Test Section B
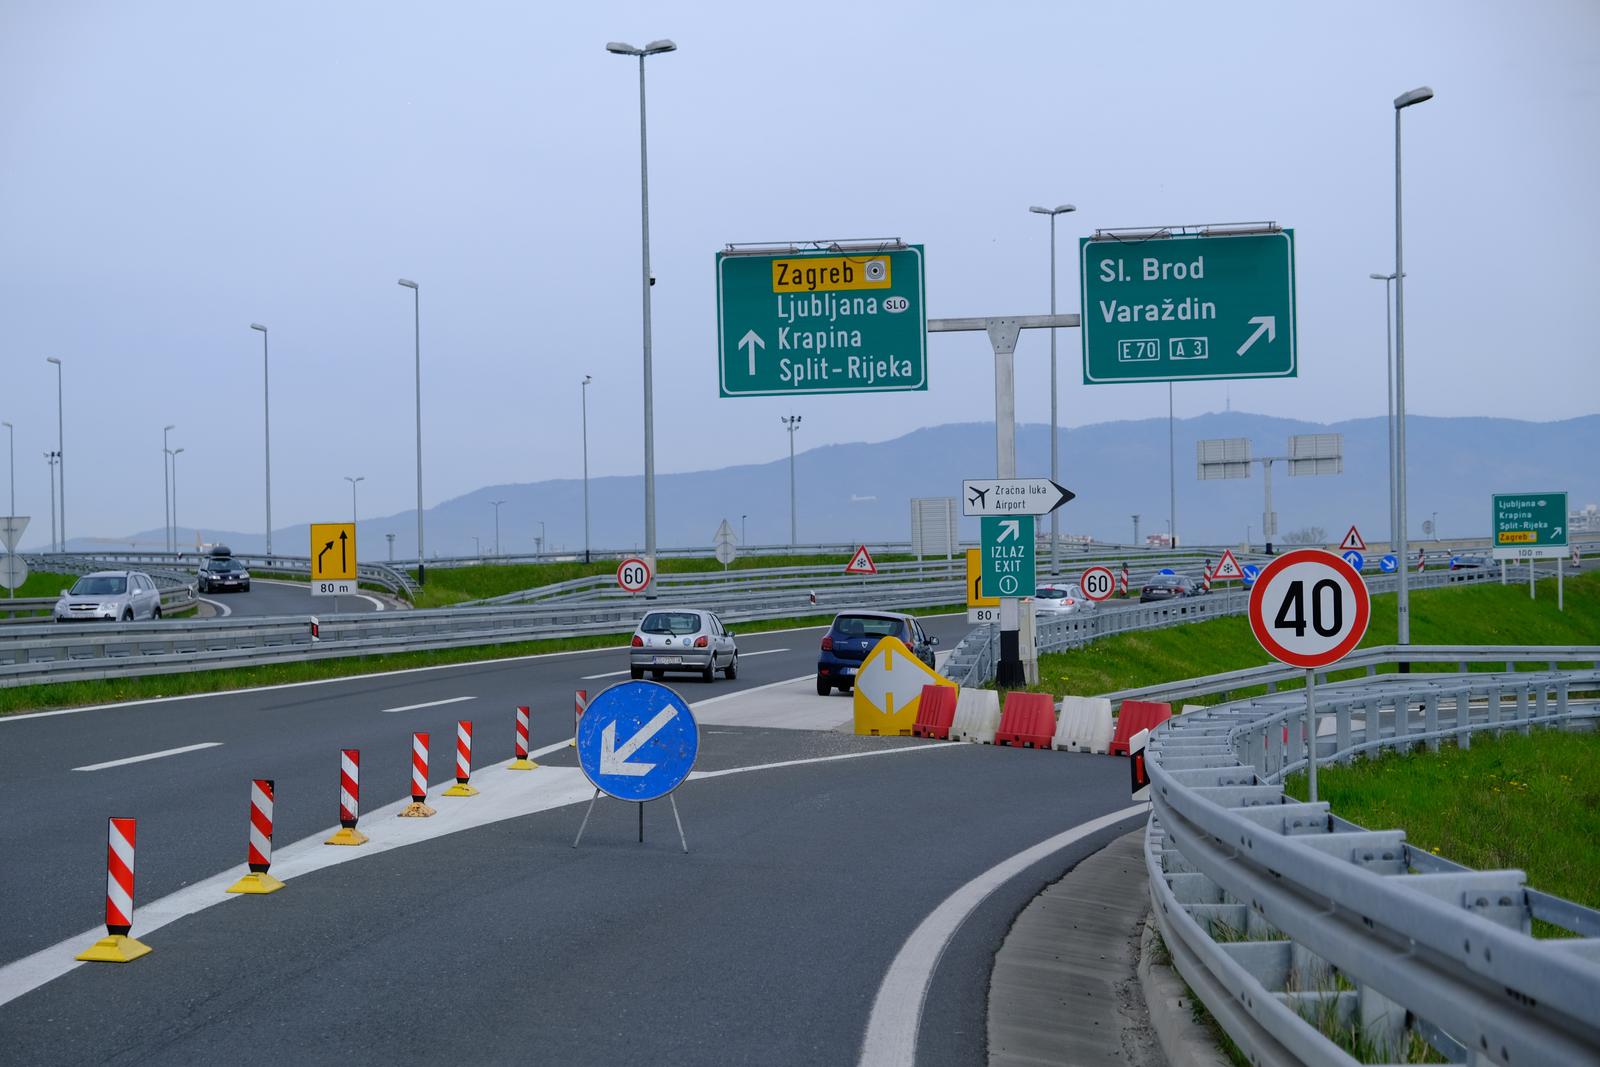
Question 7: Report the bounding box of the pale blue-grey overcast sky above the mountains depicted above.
[0,0,1600,544]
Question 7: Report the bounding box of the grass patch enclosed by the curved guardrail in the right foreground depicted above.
[1285,726,1600,907]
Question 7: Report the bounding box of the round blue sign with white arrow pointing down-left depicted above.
[578,681,699,800]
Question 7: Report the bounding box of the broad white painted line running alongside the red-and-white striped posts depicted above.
[0,741,947,1005]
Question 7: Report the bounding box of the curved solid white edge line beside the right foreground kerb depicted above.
[859,806,1150,1067]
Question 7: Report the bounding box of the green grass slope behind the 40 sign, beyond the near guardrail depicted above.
[1029,571,1600,704]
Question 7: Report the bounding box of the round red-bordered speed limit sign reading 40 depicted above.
[1250,549,1371,669]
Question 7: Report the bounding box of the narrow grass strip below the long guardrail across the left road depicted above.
[0,606,965,715]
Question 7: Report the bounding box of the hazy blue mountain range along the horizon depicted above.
[43,411,1600,560]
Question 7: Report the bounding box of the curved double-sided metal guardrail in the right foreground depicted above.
[1145,646,1600,1067]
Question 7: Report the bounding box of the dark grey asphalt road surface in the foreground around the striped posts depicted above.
[0,617,1152,1064]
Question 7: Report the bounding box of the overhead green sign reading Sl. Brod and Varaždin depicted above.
[1078,230,1296,386]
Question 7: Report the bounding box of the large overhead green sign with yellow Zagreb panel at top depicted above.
[717,245,928,397]
